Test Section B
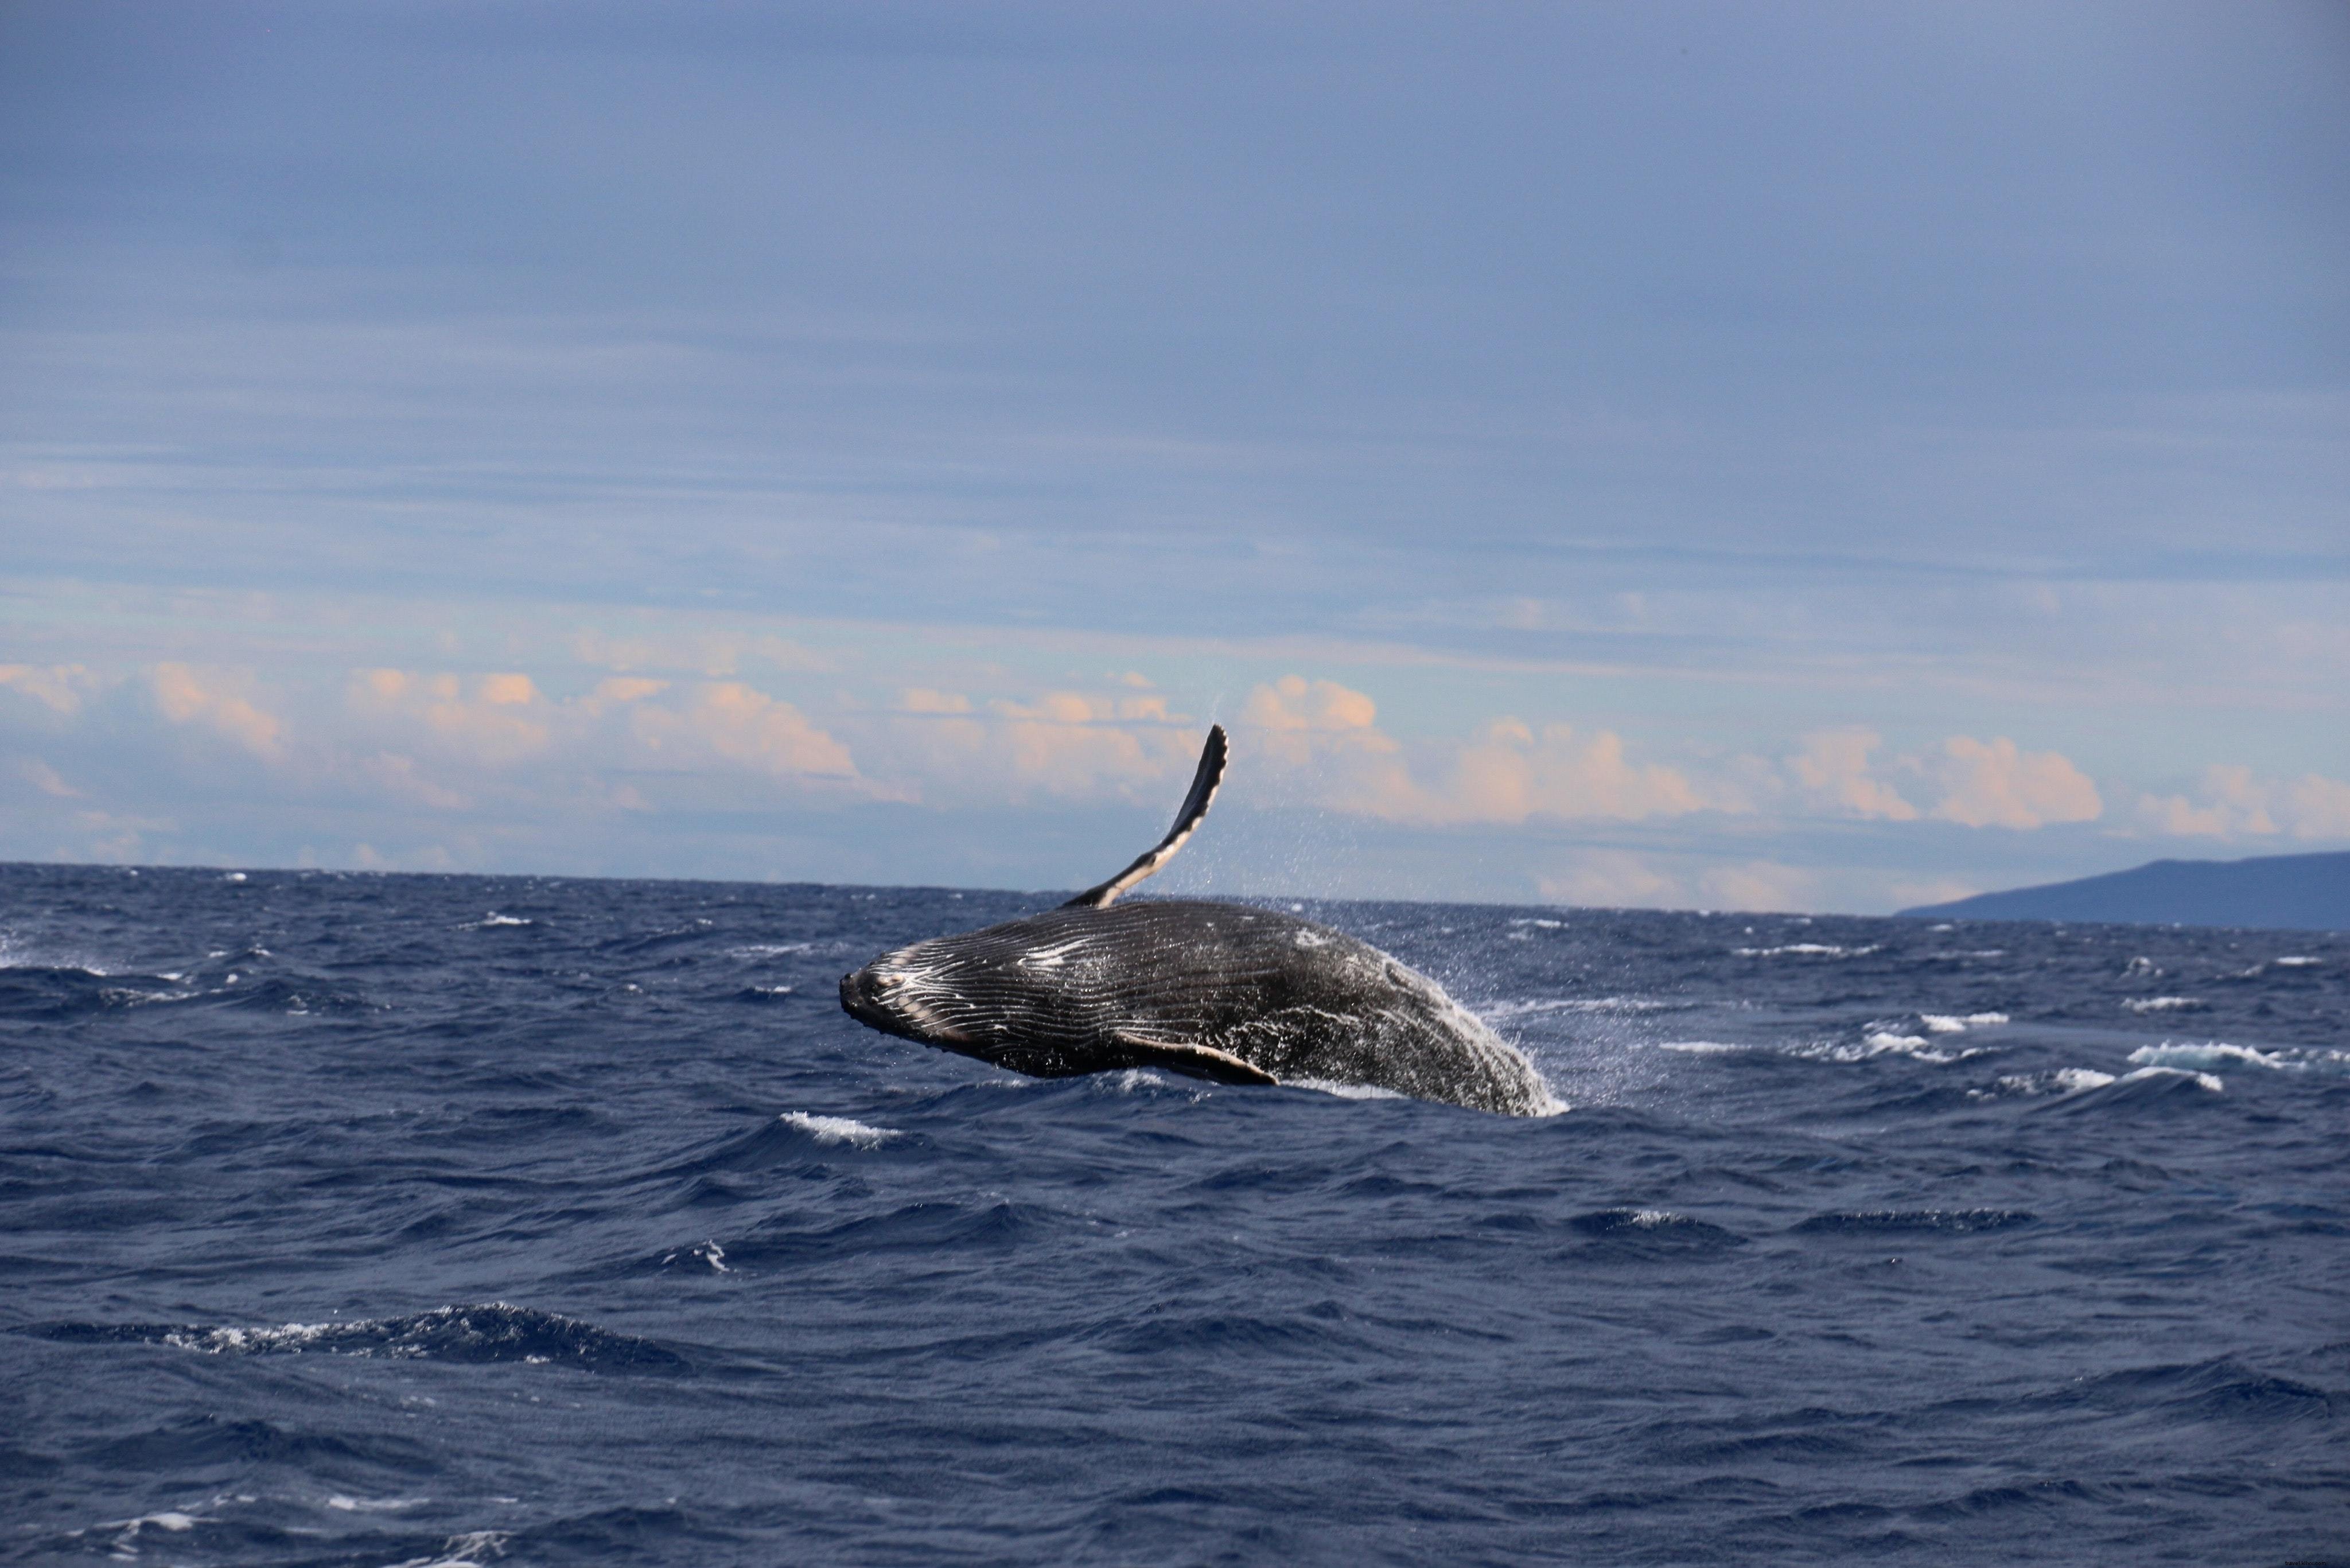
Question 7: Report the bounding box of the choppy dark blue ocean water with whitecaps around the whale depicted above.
[0,865,2350,1568]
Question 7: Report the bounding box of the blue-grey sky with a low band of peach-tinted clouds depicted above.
[0,0,2350,912]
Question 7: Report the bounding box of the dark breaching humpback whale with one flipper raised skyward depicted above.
[841,724,1563,1116]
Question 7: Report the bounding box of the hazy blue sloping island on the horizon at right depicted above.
[1901,851,2350,931]
